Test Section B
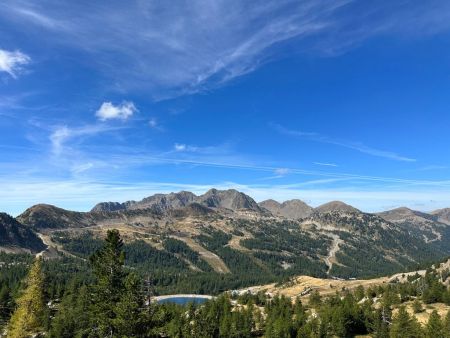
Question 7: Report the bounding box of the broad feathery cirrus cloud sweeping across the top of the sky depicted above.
[0,0,450,99]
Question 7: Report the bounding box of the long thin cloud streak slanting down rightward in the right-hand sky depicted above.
[270,123,416,162]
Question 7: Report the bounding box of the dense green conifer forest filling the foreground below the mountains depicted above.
[0,230,450,338]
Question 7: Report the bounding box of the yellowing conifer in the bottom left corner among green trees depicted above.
[8,259,46,338]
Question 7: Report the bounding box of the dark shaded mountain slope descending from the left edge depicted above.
[0,213,45,252]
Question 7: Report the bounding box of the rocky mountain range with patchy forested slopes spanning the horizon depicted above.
[0,189,450,277]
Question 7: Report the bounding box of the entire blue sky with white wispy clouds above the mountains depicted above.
[0,0,450,215]
